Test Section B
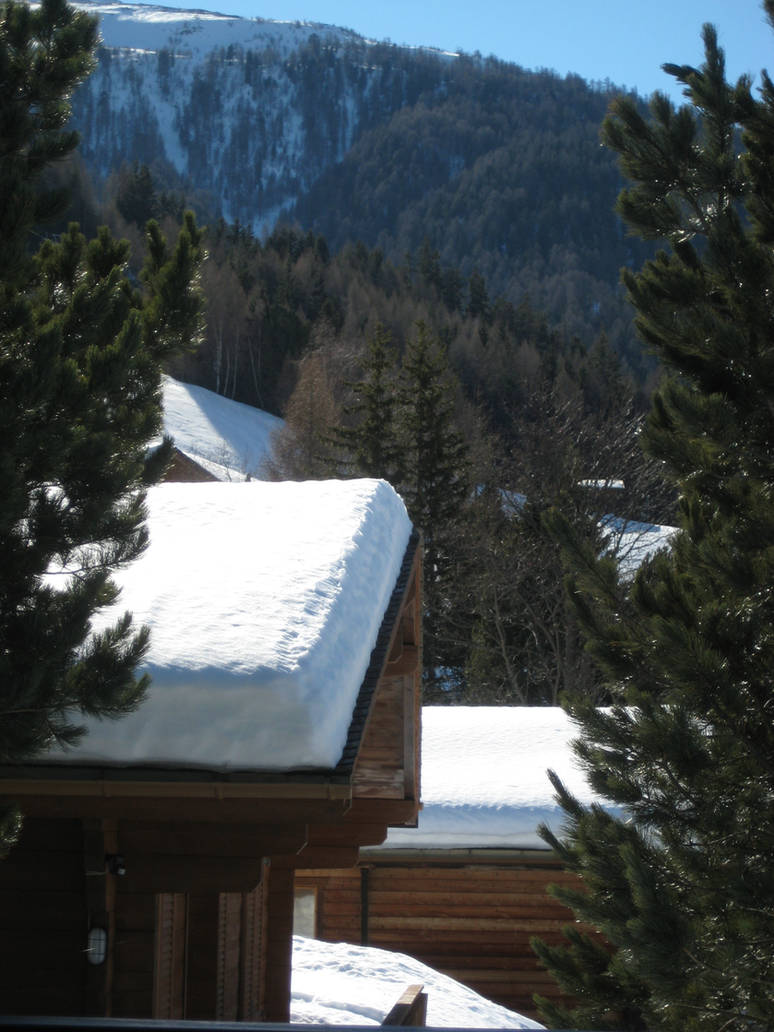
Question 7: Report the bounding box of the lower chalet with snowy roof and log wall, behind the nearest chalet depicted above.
[296,707,598,1019]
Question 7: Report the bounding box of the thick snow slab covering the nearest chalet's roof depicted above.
[47,480,411,771]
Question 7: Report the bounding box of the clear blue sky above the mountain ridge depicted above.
[139,0,774,99]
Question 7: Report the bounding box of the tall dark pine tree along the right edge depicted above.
[537,16,774,1032]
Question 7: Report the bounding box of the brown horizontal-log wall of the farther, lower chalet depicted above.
[296,850,578,1018]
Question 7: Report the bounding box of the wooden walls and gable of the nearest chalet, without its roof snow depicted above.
[0,484,421,1022]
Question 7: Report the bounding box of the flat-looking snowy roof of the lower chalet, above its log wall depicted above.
[379,706,610,849]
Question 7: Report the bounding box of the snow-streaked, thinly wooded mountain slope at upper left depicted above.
[68,0,454,230]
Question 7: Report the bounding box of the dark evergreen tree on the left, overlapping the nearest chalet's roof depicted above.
[0,0,201,830]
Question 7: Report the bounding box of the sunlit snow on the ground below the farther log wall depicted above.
[290,936,544,1029]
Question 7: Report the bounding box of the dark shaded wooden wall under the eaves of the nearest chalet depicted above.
[0,818,272,1021]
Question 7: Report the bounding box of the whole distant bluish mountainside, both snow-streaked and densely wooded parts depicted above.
[68,14,653,380]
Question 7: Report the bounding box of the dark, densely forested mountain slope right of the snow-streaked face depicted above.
[289,51,651,374]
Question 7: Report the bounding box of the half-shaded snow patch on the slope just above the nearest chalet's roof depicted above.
[163,376,283,480]
